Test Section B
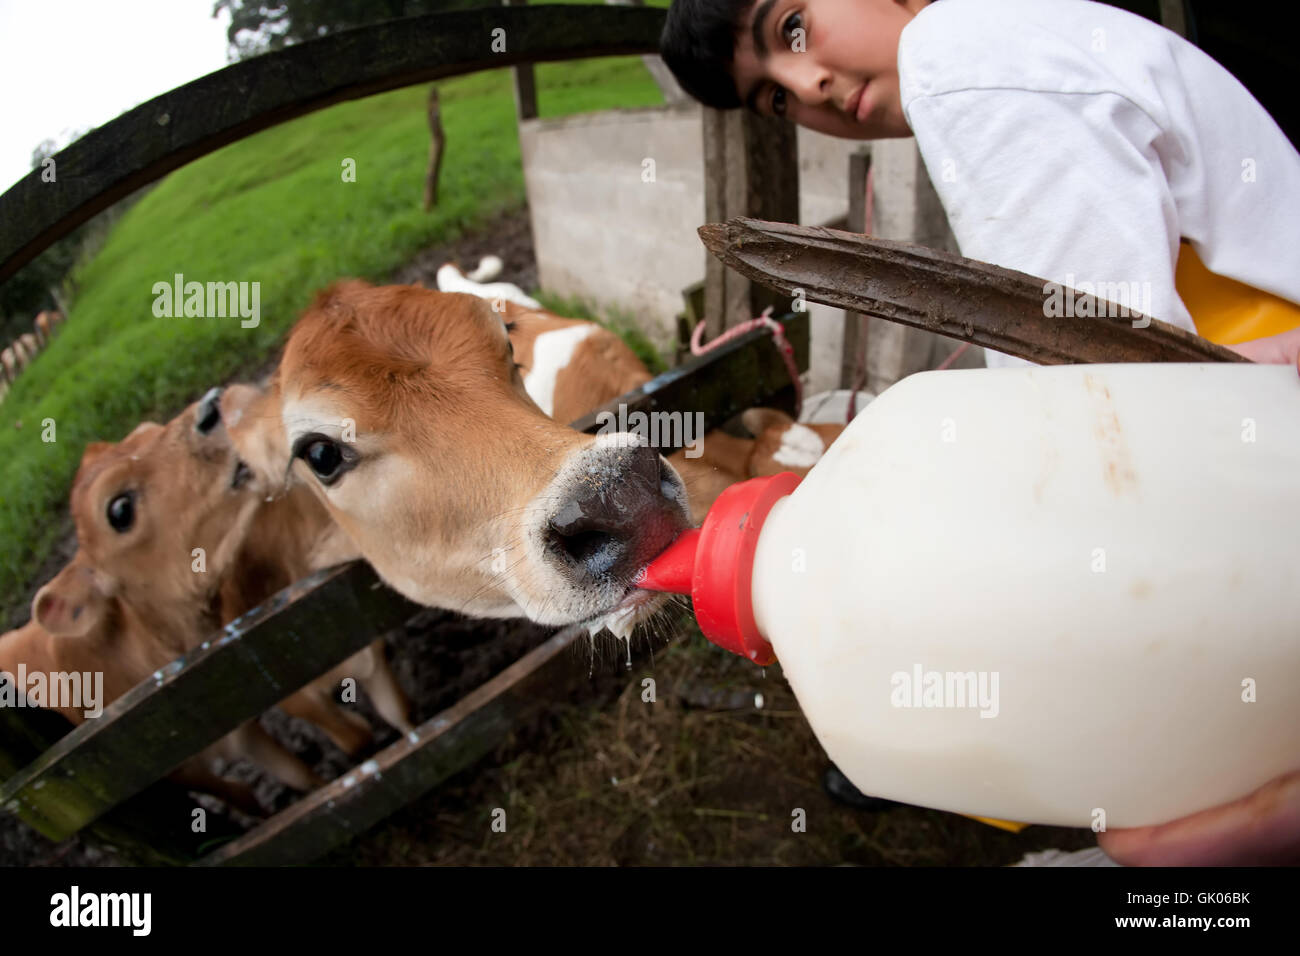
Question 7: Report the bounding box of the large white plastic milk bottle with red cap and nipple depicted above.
[644,364,1300,829]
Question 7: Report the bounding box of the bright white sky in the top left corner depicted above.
[0,0,230,193]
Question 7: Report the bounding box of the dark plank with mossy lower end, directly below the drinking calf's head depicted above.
[0,562,417,840]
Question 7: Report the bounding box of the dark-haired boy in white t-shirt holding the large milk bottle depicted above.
[660,0,1300,865]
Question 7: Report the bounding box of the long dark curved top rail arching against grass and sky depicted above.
[0,5,666,281]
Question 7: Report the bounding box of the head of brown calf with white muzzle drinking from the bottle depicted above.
[223,281,688,639]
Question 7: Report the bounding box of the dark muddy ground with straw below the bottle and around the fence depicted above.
[0,211,1095,866]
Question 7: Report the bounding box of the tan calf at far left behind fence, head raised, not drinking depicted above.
[0,394,321,814]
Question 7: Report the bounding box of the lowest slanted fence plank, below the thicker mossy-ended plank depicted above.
[199,626,588,866]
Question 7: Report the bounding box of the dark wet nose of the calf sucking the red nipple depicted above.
[546,445,688,581]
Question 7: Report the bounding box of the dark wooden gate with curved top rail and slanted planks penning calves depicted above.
[0,5,809,865]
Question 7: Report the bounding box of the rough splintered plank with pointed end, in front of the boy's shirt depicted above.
[698,219,1247,365]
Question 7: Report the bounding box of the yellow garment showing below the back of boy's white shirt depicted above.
[1174,239,1300,345]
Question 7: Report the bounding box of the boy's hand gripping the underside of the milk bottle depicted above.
[1097,770,1300,866]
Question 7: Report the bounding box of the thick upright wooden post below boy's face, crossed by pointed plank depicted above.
[703,107,800,339]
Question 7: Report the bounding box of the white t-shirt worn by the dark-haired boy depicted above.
[898,0,1300,367]
